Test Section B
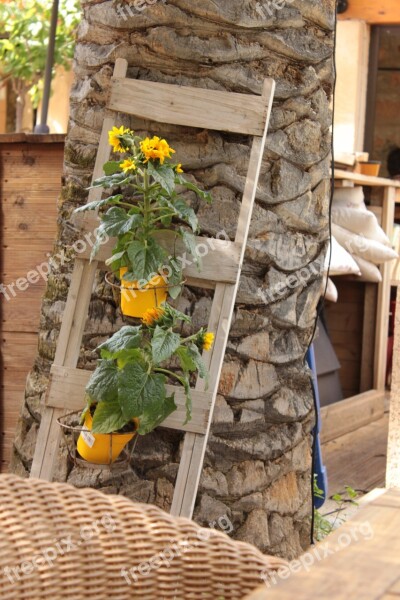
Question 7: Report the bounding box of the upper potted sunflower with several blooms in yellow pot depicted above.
[76,126,211,317]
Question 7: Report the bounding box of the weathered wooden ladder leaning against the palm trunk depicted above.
[31,59,274,518]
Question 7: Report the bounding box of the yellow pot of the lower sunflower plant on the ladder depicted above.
[76,412,139,465]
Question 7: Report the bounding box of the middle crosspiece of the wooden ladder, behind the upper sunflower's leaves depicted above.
[75,214,241,284]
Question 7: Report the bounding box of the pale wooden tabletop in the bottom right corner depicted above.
[242,490,400,600]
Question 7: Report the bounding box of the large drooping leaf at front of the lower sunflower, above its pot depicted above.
[118,362,149,421]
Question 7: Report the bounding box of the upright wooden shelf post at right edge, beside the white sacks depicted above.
[374,187,395,390]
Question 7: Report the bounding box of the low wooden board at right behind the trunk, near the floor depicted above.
[321,390,385,443]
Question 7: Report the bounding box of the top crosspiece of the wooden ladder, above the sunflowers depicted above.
[109,79,272,136]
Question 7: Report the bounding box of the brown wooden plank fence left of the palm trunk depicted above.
[0,134,65,471]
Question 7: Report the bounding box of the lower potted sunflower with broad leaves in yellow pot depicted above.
[77,304,214,464]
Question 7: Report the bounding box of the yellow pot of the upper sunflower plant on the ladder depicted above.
[120,267,168,317]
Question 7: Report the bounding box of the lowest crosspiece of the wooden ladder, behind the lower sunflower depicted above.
[46,365,212,433]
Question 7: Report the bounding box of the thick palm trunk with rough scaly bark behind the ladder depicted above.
[13,0,334,558]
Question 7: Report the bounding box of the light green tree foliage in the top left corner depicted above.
[0,0,80,129]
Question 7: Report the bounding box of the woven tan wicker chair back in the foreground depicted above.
[0,475,286,600]
